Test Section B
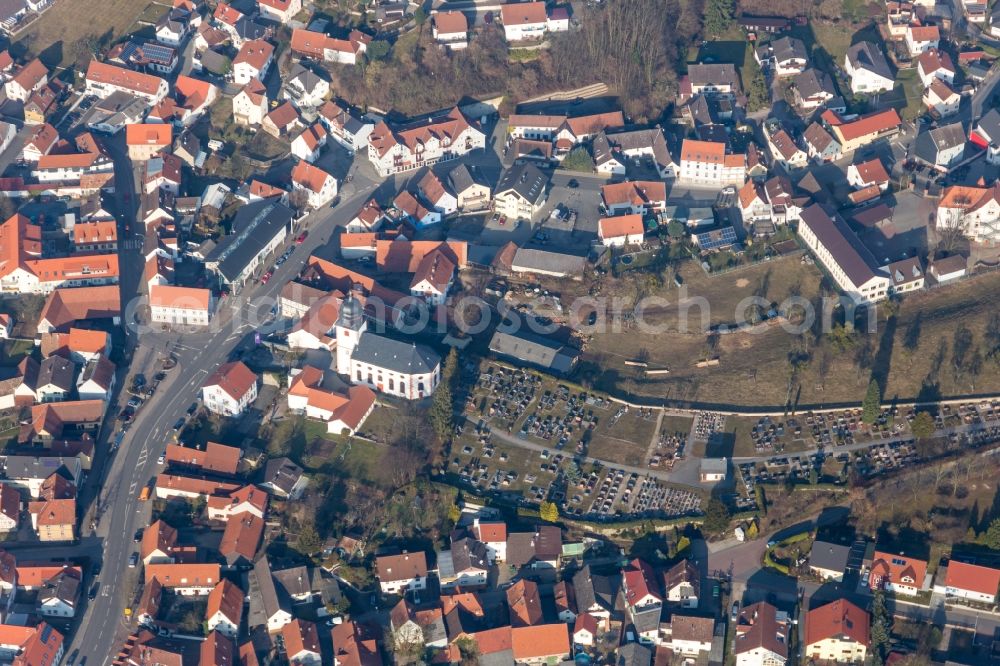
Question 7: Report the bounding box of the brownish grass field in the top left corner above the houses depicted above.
[14,0,159,67]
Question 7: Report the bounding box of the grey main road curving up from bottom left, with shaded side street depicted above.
[68,153,377,666]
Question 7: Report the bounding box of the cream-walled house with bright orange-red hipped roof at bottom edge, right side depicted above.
[803,599,871,664]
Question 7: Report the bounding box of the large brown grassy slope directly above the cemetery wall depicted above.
[586,258,1000,406]
